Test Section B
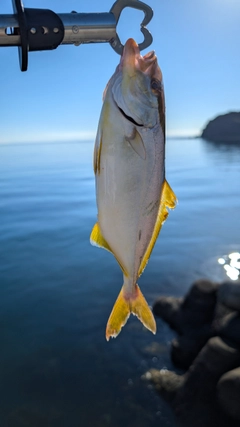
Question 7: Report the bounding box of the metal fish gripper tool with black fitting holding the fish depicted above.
[0,0,153,71]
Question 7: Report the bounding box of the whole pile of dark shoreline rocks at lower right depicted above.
[145,279,240,427]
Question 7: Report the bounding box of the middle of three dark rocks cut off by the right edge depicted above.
[216,312,240,347]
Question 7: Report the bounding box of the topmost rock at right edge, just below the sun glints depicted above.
[218,280,240,311]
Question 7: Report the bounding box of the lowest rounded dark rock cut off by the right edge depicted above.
[217,368,240,421]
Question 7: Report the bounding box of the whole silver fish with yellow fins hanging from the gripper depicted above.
[90,38,177,341]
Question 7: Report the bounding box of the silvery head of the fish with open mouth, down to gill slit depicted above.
[110,39,165,128]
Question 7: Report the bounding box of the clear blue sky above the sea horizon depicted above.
[0,0,240,142]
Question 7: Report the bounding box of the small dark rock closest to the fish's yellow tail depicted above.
[153,296,183,333]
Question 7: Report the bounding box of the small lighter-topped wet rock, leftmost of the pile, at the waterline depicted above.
[142,369,184,401]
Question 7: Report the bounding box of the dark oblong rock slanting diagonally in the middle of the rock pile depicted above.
[171,325,213,369]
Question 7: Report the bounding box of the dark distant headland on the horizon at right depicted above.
[201,112,240,143]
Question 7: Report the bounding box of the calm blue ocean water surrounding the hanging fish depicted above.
[0,139,240,427]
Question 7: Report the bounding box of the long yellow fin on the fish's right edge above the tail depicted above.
[138,180,177,277]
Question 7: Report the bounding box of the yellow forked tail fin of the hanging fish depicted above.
[106,284,156,341]
